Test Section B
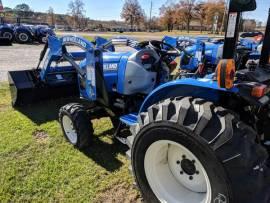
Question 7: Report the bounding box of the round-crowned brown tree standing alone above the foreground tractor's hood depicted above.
[121,0,144,30]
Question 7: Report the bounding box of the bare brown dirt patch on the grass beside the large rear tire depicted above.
[95,183,143,203]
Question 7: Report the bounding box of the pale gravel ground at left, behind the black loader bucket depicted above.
[0,44,43,82]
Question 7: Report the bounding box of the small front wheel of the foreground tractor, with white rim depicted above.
[59,103,94,149]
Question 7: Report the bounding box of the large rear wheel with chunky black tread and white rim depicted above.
[127,97,270,203]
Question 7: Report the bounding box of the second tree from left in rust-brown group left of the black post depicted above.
[178,0,196,32]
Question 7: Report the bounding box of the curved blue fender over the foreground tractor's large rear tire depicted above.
[139,76,238,113]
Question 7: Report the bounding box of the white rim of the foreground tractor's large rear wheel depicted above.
[144,140,211,203]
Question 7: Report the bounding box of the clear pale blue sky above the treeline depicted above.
[2,0,270,22]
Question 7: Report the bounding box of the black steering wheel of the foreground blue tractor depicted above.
[148,40,181,57]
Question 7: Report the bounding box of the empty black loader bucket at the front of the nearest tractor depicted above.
[8,70,79,107]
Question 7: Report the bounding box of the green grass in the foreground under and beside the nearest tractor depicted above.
[0,83,140,202]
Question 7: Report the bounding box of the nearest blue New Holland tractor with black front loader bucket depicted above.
[9,0,270,203]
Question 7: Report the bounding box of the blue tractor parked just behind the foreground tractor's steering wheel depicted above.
[162,36,224,77]
